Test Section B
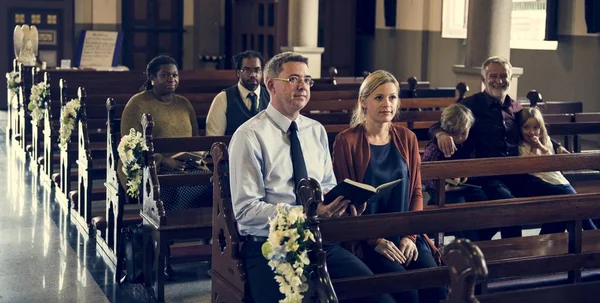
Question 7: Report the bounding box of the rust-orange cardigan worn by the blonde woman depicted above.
[333,124,438,256]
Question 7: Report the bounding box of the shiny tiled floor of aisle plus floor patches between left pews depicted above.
[0,111,210,303]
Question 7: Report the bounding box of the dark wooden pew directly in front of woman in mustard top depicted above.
[140,114,228,302]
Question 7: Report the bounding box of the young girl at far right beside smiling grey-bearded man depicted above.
[519,107,596,234]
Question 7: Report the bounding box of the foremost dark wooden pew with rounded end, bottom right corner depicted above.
[444,239,600,303]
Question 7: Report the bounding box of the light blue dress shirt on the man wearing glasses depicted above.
[228,104,336,236]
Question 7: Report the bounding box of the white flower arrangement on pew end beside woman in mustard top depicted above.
[117,128,148,199]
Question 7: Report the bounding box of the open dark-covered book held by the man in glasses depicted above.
[323,179,402,207]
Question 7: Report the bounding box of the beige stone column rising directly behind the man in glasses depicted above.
[281,0,325,79]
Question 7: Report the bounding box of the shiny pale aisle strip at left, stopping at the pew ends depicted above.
[0,126,109,302]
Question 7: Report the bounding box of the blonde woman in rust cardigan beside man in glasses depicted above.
[333,70,447,302]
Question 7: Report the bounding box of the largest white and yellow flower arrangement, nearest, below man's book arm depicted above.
[262,203,315,303]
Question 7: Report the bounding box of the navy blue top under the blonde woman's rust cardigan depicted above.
[362,142,410,245]
